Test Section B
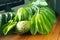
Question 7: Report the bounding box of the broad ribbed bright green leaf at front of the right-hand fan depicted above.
[38,12,52,34]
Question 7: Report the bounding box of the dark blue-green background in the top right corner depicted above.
[47,0,60,15]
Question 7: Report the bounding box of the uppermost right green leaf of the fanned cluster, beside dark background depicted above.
[41,7,56,23]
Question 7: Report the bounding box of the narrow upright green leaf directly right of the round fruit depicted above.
[30,14,39,35]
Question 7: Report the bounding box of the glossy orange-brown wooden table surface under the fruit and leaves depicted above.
[0,16,60,40]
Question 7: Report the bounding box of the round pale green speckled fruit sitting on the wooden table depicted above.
[16,21,30,34]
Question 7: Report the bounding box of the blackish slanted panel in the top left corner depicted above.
[0,0,24,11]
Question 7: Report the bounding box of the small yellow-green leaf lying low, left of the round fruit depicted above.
[3,21,16,35]
